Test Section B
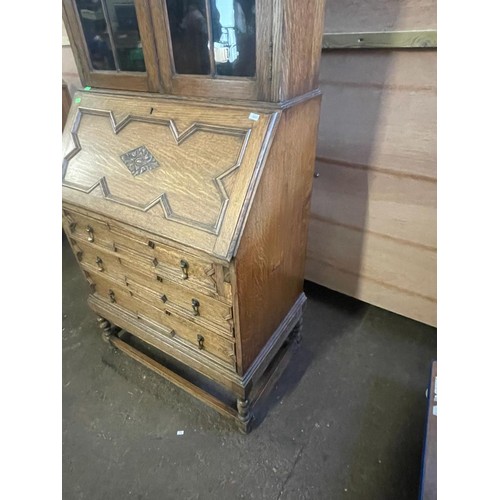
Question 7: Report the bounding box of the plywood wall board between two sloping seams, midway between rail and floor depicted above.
[311,161,436,250]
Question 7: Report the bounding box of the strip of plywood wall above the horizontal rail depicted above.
[325,0,437,33]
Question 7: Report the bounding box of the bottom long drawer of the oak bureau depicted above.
[86,272,236,368]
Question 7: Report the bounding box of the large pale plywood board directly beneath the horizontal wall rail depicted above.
[317,51,436,178]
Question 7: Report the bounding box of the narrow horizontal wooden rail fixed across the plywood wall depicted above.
[322,30,437,50]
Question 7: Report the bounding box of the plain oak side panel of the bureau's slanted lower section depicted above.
[233,97,321,374]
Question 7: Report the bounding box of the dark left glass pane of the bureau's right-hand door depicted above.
[166,0,210,75]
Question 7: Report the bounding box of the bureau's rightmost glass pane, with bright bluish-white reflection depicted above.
[210,0,256,76]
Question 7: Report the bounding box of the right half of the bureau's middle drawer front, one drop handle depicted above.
[126,272,233,337]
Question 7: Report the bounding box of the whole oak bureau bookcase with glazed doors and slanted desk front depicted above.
[62,0,324,432]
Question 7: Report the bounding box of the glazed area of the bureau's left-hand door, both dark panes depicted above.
[75,0,146,72]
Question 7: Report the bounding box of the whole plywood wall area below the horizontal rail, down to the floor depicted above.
[306,50,436,325]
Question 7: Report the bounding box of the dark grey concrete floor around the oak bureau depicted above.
[62,238,436,500]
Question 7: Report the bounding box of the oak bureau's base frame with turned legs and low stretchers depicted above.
[93,294,305,434]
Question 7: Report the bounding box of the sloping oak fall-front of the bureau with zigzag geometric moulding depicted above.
[63,92,275,260]
